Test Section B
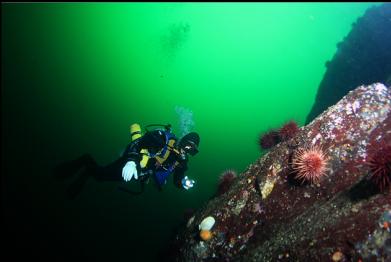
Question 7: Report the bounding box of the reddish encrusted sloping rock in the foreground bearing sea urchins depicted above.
[168,84,391,261]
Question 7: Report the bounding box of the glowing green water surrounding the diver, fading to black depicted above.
[1,3,380,261]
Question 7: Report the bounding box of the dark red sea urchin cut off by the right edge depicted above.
[368,142,391,191]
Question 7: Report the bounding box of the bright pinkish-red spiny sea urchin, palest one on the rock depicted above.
[292,143,329,183]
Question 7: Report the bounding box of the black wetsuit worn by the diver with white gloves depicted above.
[54,130,188,197]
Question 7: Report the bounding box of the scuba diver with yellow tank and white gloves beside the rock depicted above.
[54,124,200,198]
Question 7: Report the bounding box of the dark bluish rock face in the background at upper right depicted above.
[306,3,391,124]
